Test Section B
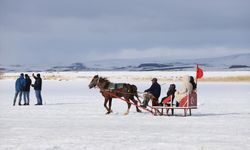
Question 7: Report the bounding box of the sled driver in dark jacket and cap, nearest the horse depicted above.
[141,78,161,107]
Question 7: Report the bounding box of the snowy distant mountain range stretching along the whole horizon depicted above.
[0,53,250,72]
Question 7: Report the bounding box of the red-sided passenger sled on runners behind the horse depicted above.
[152,91,197,116]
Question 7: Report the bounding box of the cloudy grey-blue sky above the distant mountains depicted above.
[0,0,250,64]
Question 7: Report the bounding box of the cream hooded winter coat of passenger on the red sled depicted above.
[175,76,193,102]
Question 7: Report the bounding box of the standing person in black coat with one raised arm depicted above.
[31,73,43,105]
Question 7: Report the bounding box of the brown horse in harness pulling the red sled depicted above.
[89,75,141,115]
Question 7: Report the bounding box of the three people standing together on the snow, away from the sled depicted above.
[13,73,43,106]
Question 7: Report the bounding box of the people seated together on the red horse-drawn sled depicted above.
[141,76,197,107]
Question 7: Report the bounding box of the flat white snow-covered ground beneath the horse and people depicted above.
[0,72,250,150]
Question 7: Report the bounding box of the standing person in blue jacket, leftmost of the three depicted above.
[13,73,26,106]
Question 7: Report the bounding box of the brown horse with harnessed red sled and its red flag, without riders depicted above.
[89,66,203,116]
